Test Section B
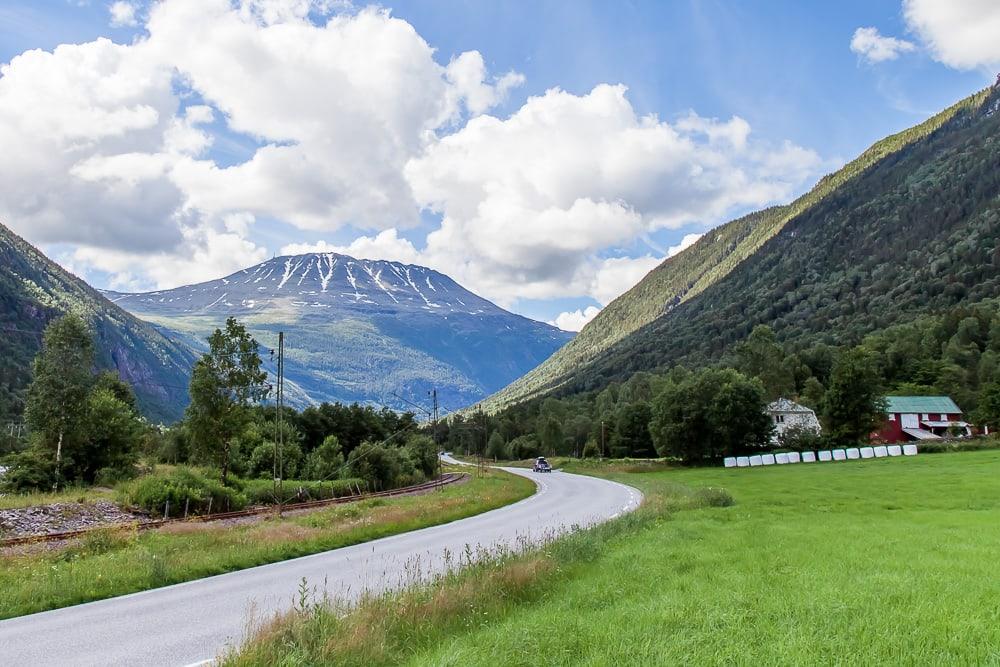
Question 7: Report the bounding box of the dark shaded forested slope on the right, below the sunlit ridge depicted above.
[566,81,1000,391]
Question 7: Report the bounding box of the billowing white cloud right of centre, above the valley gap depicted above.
[405,85,820,303]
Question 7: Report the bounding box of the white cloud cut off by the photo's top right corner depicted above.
[903,0,1000,73]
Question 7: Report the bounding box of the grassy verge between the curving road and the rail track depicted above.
[0,471,535,618]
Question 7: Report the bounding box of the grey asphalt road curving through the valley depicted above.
[0,468,642,667]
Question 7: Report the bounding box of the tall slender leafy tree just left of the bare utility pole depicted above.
[187,317,267,484]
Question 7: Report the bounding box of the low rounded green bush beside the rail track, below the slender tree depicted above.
[117,468,247,517]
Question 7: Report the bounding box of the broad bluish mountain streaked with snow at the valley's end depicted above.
[105,253,572,409]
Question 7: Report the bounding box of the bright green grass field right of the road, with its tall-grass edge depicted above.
[228,451,1000,665]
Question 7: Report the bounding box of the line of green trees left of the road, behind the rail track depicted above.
[2,315,438,491]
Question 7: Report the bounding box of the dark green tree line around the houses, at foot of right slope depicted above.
[468,301,1000,461]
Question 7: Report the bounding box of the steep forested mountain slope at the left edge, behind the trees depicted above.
[0,225,194,422]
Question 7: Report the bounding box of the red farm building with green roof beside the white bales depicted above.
[877,396,972,443]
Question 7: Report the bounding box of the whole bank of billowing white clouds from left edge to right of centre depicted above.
[0,0,821,306]
